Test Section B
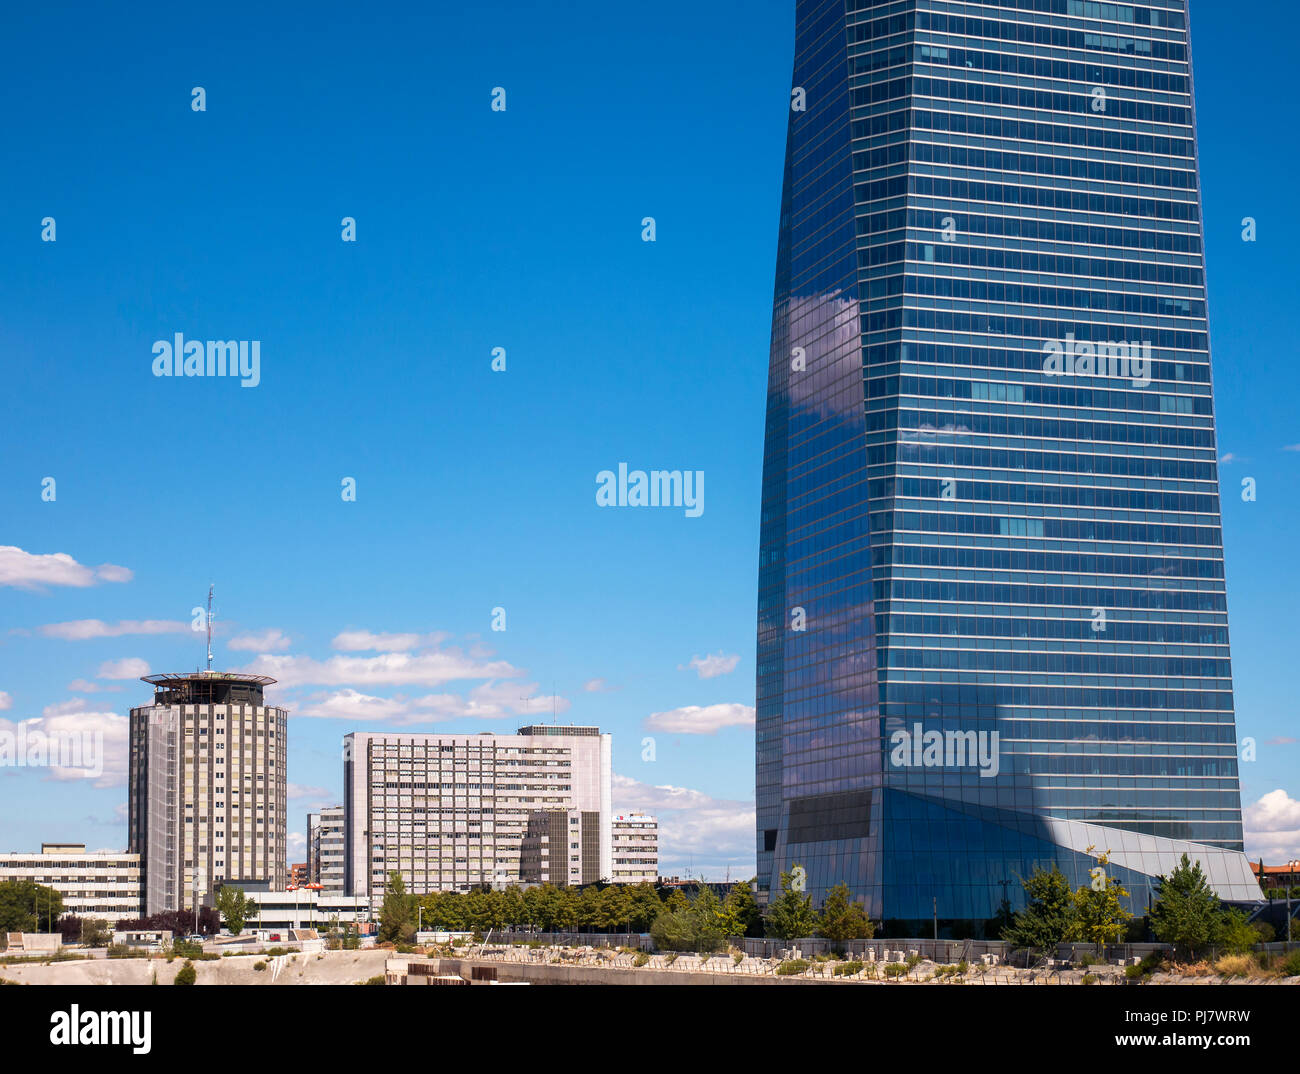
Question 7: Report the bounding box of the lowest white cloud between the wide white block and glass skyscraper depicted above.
[614,774,754,879]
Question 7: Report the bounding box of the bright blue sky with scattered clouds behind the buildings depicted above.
[0,0,1300,876]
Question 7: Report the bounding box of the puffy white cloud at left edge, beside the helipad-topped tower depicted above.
[0,701,130,787]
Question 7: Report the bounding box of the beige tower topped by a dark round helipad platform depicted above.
[127,671,289,914]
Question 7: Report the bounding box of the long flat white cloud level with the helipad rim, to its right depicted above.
[239,649,520,687]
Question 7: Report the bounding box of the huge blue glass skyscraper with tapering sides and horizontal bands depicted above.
[757,0,1260,935]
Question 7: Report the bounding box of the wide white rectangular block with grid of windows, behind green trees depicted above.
[343,724,614,905]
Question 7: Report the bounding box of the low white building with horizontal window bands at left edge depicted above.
[0,843,142,915]
